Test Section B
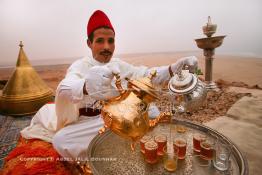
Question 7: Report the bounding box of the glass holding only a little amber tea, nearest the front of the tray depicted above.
[163,147,178,172]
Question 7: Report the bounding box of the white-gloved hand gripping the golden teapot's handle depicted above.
[84,66,119,100]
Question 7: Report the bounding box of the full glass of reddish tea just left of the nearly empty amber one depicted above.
[145,140,157,164]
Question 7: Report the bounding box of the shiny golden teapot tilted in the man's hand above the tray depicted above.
[101,71,168,145]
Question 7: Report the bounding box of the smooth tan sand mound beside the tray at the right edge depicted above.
[205,88,262,175]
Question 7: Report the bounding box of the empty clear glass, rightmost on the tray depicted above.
[213,140,232,171]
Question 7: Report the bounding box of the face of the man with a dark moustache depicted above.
[87,28,115,63]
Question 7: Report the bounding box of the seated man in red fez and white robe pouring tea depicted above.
[21,10,197,161]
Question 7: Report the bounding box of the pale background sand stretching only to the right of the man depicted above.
[120,52,262,87]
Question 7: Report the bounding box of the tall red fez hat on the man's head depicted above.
[87,10,115,36]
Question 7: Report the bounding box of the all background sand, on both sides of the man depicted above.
[0,52,262,90]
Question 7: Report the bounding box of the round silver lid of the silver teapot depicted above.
[168,70,197,94]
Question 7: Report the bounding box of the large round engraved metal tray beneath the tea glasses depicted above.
[88,119,248,175]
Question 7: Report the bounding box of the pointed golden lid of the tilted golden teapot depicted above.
[127,72,158,99]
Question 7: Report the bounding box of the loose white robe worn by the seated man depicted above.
[21,57,162,160]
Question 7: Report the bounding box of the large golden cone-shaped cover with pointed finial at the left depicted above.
[0,41,53,116]
